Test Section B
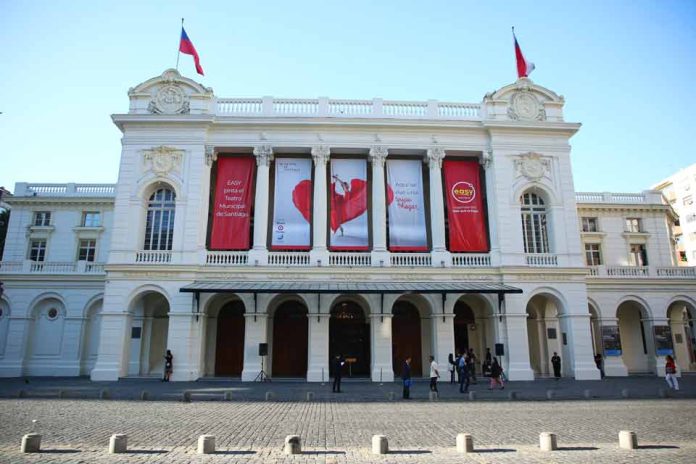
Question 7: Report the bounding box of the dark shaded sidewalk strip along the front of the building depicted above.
[0,374,696,402]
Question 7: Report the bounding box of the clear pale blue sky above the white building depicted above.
[0,0,696,192]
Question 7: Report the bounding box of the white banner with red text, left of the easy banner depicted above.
[387,160,428,251]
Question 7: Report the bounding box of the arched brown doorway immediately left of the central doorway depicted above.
[272,300,308,377]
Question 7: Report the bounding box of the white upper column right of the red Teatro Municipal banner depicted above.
[249,145,273,266]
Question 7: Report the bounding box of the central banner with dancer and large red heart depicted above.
[329,159,370,250]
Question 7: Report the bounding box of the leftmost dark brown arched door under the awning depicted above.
[215,301,244,377]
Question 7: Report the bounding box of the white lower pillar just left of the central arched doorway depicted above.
[304,294,336,382]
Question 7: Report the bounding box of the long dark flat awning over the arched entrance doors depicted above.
[179,281,522,296]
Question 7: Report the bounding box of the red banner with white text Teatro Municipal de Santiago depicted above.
[210,156,254,250]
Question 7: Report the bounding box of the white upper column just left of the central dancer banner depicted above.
[309,145,331,266]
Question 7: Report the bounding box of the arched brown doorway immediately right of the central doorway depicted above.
[392,301,423,377]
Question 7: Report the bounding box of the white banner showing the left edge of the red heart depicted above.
[271,158,312,250]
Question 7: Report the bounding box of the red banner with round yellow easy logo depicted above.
[443,159,488,252]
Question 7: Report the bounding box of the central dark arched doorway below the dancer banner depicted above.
[329,301,370,377]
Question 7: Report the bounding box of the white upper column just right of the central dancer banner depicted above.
[370,145,391,267]
